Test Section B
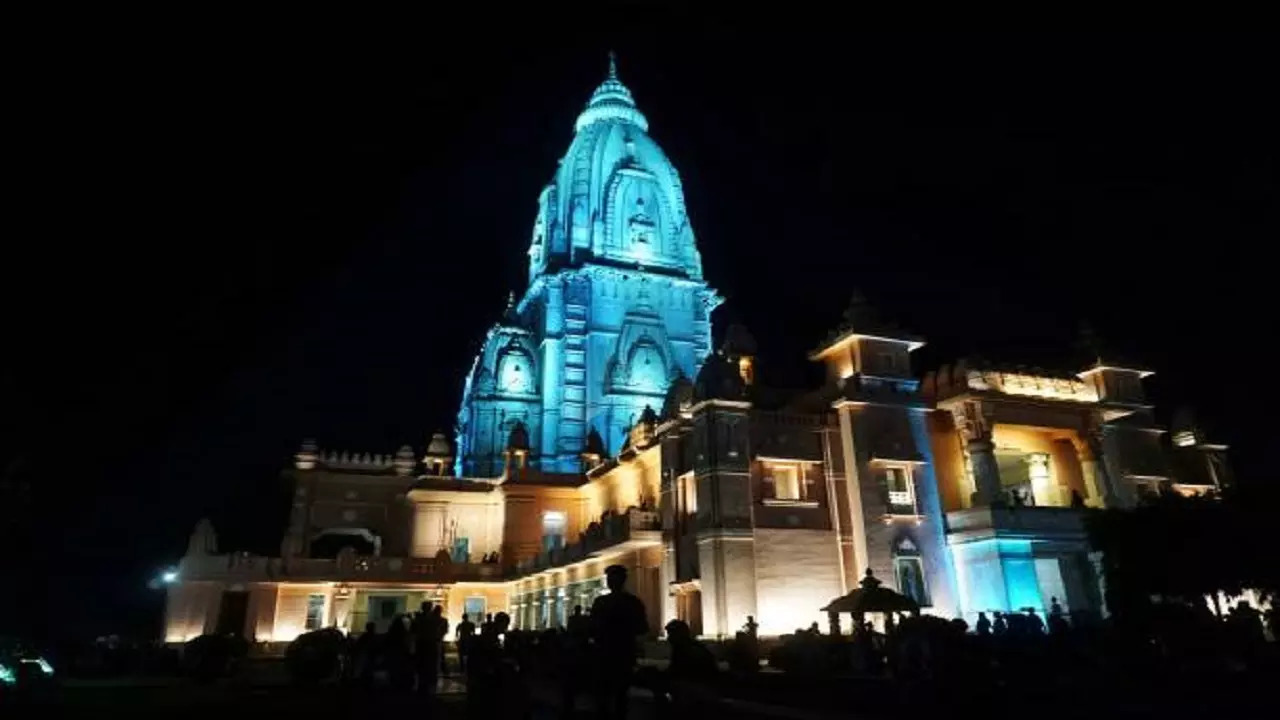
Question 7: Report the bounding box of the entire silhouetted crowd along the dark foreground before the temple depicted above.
[320,566,1262,719]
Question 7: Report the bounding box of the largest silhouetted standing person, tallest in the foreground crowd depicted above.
[591,565,649,720]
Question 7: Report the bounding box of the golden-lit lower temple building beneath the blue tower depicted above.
[166,313,1229,638]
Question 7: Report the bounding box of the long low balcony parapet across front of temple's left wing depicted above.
[179,553,502,584]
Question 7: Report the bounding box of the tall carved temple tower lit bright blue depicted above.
[457,55,721,475]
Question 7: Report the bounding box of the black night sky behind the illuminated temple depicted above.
[0,23,1280,634]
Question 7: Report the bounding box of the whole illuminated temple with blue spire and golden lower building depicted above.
[165,57,1230,651]
